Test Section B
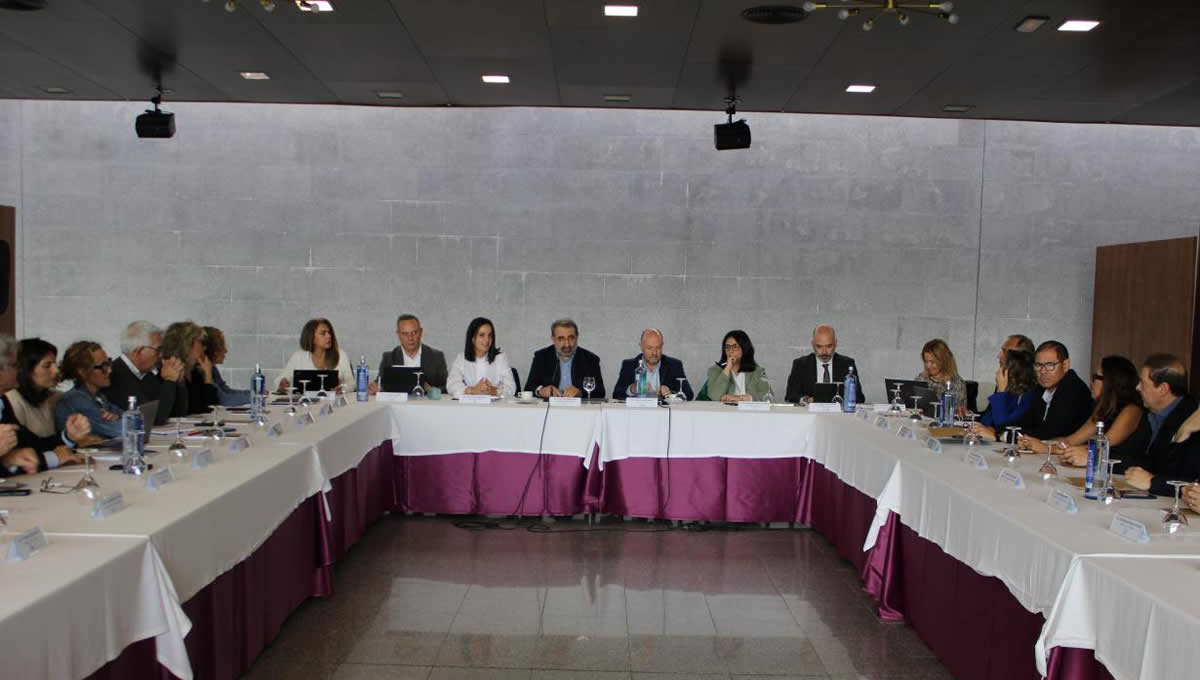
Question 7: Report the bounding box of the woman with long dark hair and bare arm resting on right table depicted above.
[1021,355,1150,462]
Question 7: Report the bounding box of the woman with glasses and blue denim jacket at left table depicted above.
[54,341,125,439]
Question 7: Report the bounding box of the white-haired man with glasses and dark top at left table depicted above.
[104,321,187,425]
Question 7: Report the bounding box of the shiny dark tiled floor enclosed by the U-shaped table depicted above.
[241,516,952,680]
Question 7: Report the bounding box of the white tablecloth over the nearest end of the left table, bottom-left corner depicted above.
[0,532,192,680]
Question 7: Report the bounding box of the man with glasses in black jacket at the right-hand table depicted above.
[1018,341,1092,440]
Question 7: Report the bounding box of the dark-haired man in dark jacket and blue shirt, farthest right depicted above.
[1115,354,1200,495]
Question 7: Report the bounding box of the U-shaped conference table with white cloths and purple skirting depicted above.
[0,399,1200,680]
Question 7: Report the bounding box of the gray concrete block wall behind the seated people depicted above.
[0,102,1200,398]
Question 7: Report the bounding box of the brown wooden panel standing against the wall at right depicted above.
[1094,236,1200,384]
